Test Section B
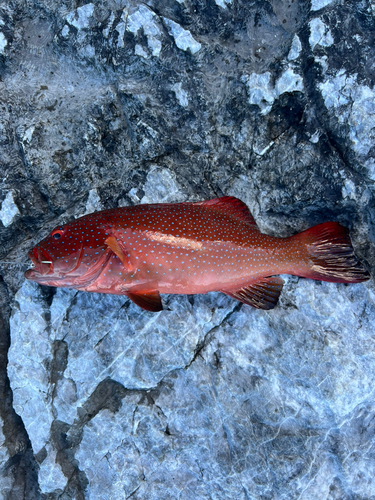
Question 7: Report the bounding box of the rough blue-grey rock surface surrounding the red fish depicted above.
[0,0,375,500]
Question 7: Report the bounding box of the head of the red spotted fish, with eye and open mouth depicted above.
[25,216,108,287]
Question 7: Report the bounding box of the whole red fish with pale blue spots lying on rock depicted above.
[25,196,370,312]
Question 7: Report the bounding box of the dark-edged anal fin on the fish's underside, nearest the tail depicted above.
[221,276,284,309]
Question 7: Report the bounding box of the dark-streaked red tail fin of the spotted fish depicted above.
[292,222,370,283]
